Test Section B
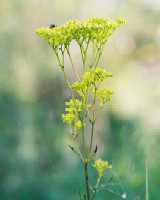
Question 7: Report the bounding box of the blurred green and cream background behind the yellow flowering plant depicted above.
[0,0,160,200]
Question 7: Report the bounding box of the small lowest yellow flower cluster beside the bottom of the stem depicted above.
[92,159,112,177]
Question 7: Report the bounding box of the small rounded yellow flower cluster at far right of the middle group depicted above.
[97,87,114,107]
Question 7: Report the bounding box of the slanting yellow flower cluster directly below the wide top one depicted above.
[72,68,112,96]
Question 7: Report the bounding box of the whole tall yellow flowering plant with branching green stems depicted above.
[35,17,125,200]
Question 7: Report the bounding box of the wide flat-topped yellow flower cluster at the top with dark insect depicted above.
[35,17,125,49]
